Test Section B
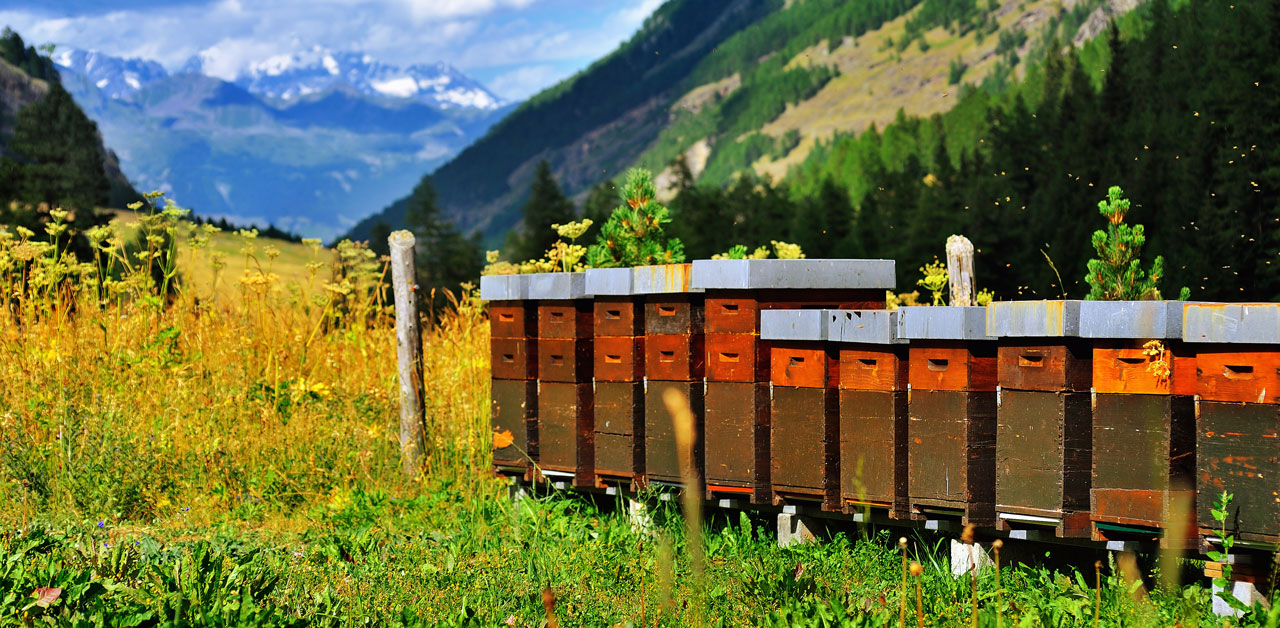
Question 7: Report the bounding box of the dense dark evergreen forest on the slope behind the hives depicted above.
[650,0,1280,301]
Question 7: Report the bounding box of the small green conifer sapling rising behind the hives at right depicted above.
[1084,185,1190,301]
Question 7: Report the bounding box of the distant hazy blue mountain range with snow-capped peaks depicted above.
[54,47,511,238]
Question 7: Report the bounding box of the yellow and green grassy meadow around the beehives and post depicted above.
[0,204,1276,627]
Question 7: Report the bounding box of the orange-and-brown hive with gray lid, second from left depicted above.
[529,272,595,486]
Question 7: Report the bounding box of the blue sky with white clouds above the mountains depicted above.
[0,0,662,100]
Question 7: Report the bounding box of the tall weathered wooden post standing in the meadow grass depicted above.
[387,230,426,477]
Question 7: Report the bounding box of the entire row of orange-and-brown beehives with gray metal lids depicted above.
[481,260,1280,546]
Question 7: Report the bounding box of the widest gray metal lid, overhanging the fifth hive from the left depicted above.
[692,260,893,290]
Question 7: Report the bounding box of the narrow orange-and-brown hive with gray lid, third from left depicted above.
[586,269,645,486]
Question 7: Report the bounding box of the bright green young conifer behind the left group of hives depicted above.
[586,168,685,269]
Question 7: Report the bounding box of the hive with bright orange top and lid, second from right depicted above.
[1080,301,1196,549]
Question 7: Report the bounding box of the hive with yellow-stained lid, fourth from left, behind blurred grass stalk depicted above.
[632,263,704,490]
